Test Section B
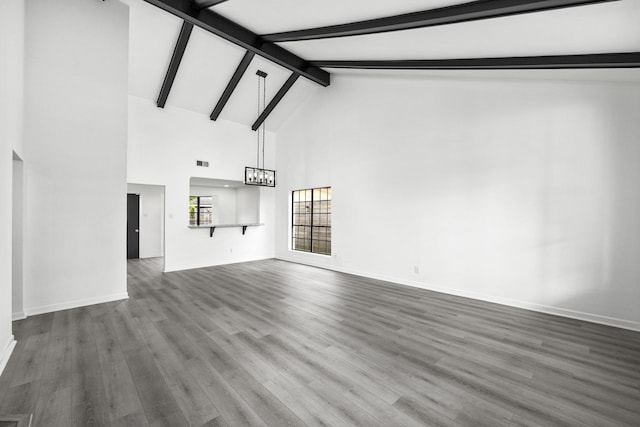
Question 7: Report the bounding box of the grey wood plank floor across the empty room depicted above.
[0,259,640,427]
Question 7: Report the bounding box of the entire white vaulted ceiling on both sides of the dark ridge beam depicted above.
[122,0,640,130]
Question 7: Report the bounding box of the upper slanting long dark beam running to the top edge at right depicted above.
[262,0,618,42]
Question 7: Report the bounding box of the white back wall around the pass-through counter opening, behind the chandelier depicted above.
[127,96,275,271]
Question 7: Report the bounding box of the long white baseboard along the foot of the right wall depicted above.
[277,257,640,332]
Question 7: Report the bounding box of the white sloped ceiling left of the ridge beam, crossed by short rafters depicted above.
[123,0,317,130]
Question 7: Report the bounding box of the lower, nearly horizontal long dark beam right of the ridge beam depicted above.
[310,52,640,70]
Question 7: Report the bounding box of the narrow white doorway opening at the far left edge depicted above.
[11,151,25,320]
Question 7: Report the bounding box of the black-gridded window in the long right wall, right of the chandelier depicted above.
[291,187,331,255]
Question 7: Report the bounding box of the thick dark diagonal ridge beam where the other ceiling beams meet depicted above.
[145,0,330,86]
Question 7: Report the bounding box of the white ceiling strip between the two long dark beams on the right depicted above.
[280,0,640,60]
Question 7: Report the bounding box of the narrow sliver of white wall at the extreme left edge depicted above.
[0,0,24,374]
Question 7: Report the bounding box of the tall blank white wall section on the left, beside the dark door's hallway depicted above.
[24,0,128,315]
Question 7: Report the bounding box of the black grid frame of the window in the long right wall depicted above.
[289,186,333,257]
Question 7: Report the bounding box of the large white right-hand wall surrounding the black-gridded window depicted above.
[276,76,640,329]
